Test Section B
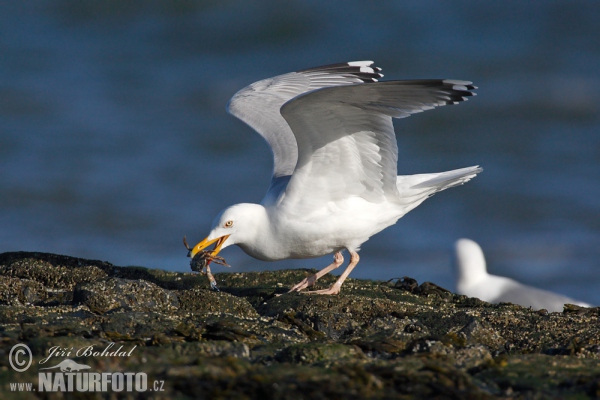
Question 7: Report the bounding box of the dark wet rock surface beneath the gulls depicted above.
[0,252,600,399]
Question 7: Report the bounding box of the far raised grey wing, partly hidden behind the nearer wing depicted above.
[227,61,383,200]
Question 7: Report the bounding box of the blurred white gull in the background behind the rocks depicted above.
[454,239,591,312]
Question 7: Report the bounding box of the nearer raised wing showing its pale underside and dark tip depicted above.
[281,80,475,212]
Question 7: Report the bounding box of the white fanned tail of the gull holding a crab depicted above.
[396,165,483,212]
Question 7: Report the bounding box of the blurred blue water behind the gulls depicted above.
[0,0,600,304]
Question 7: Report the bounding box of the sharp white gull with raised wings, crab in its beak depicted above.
[188,61,482,295]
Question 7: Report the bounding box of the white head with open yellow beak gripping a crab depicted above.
[190,203,264,258]
